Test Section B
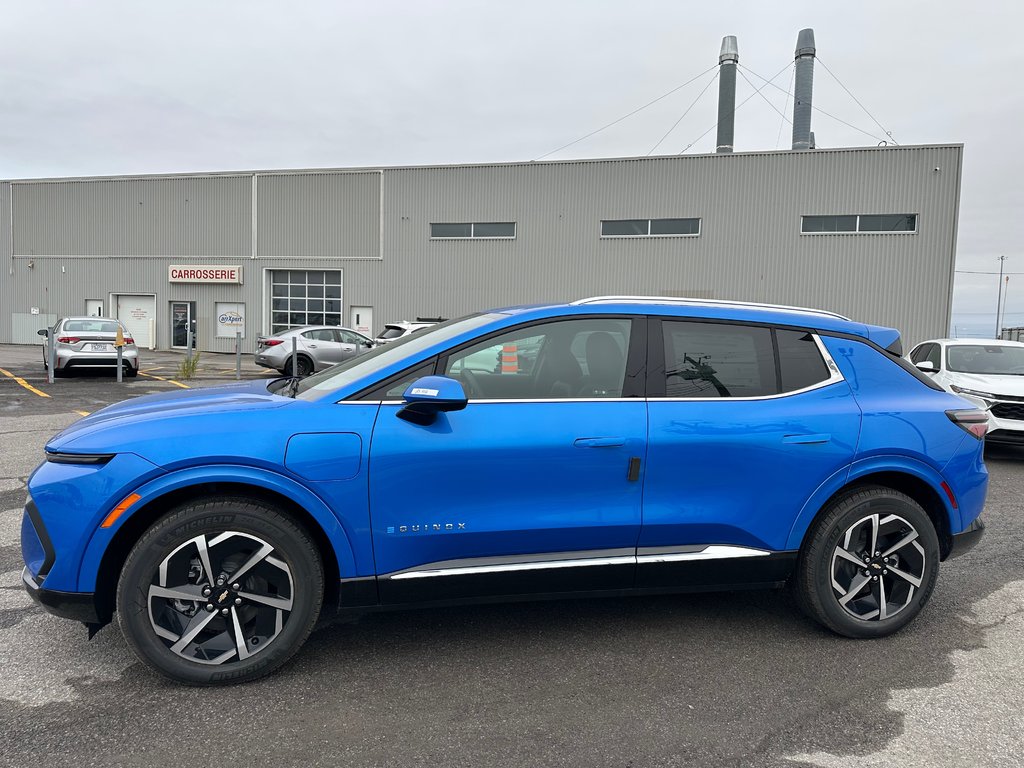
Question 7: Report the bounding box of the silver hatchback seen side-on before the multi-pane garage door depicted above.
[256,326,375,376]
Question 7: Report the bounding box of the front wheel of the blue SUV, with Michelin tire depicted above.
[118,497,324,685]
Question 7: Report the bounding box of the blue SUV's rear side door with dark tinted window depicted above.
[637,318,861,587]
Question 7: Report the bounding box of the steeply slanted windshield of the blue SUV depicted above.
[295,312,502,400]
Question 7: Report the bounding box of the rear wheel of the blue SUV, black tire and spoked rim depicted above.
[794,486,939,638]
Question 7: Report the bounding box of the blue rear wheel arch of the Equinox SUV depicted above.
[787,462,958,560]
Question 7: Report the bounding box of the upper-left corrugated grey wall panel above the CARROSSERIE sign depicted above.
[14,176,251,257]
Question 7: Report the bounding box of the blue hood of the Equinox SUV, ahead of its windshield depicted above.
[46,380,295,453]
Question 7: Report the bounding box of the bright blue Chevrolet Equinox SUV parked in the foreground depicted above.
[22,297,988,685]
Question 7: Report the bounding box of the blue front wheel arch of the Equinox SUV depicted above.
[79,468,355,624]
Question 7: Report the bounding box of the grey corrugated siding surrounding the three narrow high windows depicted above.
[382,146,962,343]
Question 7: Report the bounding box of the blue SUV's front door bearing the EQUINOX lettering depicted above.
[370,316,647,603]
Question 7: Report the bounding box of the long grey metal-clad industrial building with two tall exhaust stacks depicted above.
[0,31,963,352]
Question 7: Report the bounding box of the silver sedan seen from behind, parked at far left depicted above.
[38,317,138,376]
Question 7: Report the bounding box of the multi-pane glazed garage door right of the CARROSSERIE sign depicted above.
[270,269,341,333]
